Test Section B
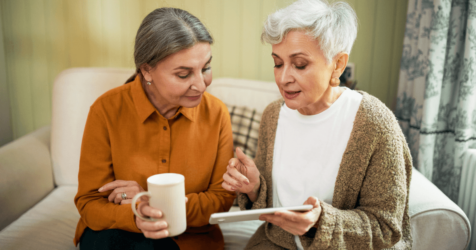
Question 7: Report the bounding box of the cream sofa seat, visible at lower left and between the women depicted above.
[0,183,263,250]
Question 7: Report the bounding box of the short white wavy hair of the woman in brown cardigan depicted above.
[261,0,357,63]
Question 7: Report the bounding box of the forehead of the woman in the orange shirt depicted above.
[157,43,212,68]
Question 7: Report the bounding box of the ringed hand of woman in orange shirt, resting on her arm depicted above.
[98,180,145,205]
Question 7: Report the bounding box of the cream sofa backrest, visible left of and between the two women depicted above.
[51,68,280,185]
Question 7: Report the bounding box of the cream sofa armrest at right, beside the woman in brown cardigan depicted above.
[409,168,471,250]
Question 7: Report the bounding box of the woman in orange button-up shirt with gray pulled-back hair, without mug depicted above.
[74,8,235,250]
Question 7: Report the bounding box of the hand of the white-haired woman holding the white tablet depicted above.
[259,196,322,235]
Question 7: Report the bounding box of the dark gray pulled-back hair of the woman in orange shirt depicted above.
[126,8,213,83]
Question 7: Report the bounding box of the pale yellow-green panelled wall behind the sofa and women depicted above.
[0,0,407,138]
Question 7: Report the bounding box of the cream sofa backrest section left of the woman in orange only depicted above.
[51,68,134,185]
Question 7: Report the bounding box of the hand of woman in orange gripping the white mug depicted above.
[134,196,188,239]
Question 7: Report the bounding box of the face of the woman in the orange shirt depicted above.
[142,42,212,111]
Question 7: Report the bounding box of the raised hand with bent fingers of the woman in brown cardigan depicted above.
[221,148,260,202]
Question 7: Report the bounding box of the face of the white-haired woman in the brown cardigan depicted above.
[272,31,335,114]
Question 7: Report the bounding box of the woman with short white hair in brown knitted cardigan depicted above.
[223,0,412,250]
